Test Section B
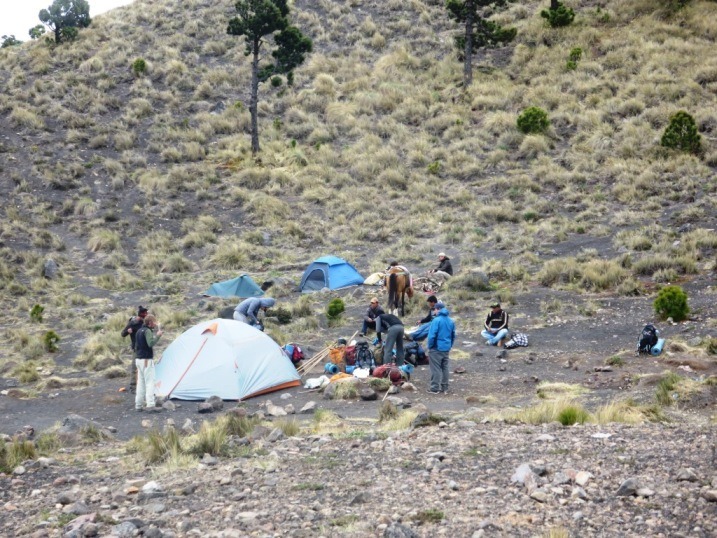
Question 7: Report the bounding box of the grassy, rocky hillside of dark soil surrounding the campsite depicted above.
[0,0,717,537]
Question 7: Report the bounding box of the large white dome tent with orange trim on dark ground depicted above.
[155,319,300,400]
